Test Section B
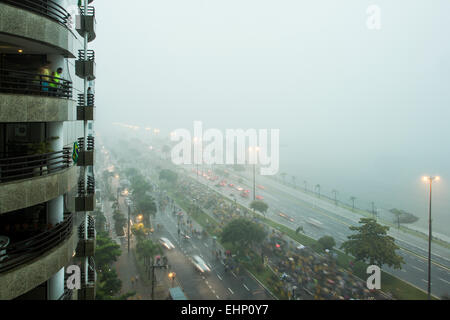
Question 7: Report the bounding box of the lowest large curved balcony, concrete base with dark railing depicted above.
[0,214,76,300]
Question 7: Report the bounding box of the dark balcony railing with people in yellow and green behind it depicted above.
[0,69,72,99]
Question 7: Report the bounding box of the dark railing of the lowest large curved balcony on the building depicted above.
[0,213,73,273]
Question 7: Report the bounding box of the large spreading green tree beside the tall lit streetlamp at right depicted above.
[341,218,404,269]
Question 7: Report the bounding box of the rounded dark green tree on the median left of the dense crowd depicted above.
[221,218,266,248]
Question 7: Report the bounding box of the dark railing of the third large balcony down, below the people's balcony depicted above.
[0,148,72,183]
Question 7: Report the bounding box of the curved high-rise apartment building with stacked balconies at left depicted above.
[0,0,96,300]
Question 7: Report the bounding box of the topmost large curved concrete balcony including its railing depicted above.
[0,0,75,58]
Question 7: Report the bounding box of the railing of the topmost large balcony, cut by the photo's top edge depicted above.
[0,0,70,26]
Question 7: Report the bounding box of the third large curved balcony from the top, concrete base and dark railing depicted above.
[0,148,77,214]
